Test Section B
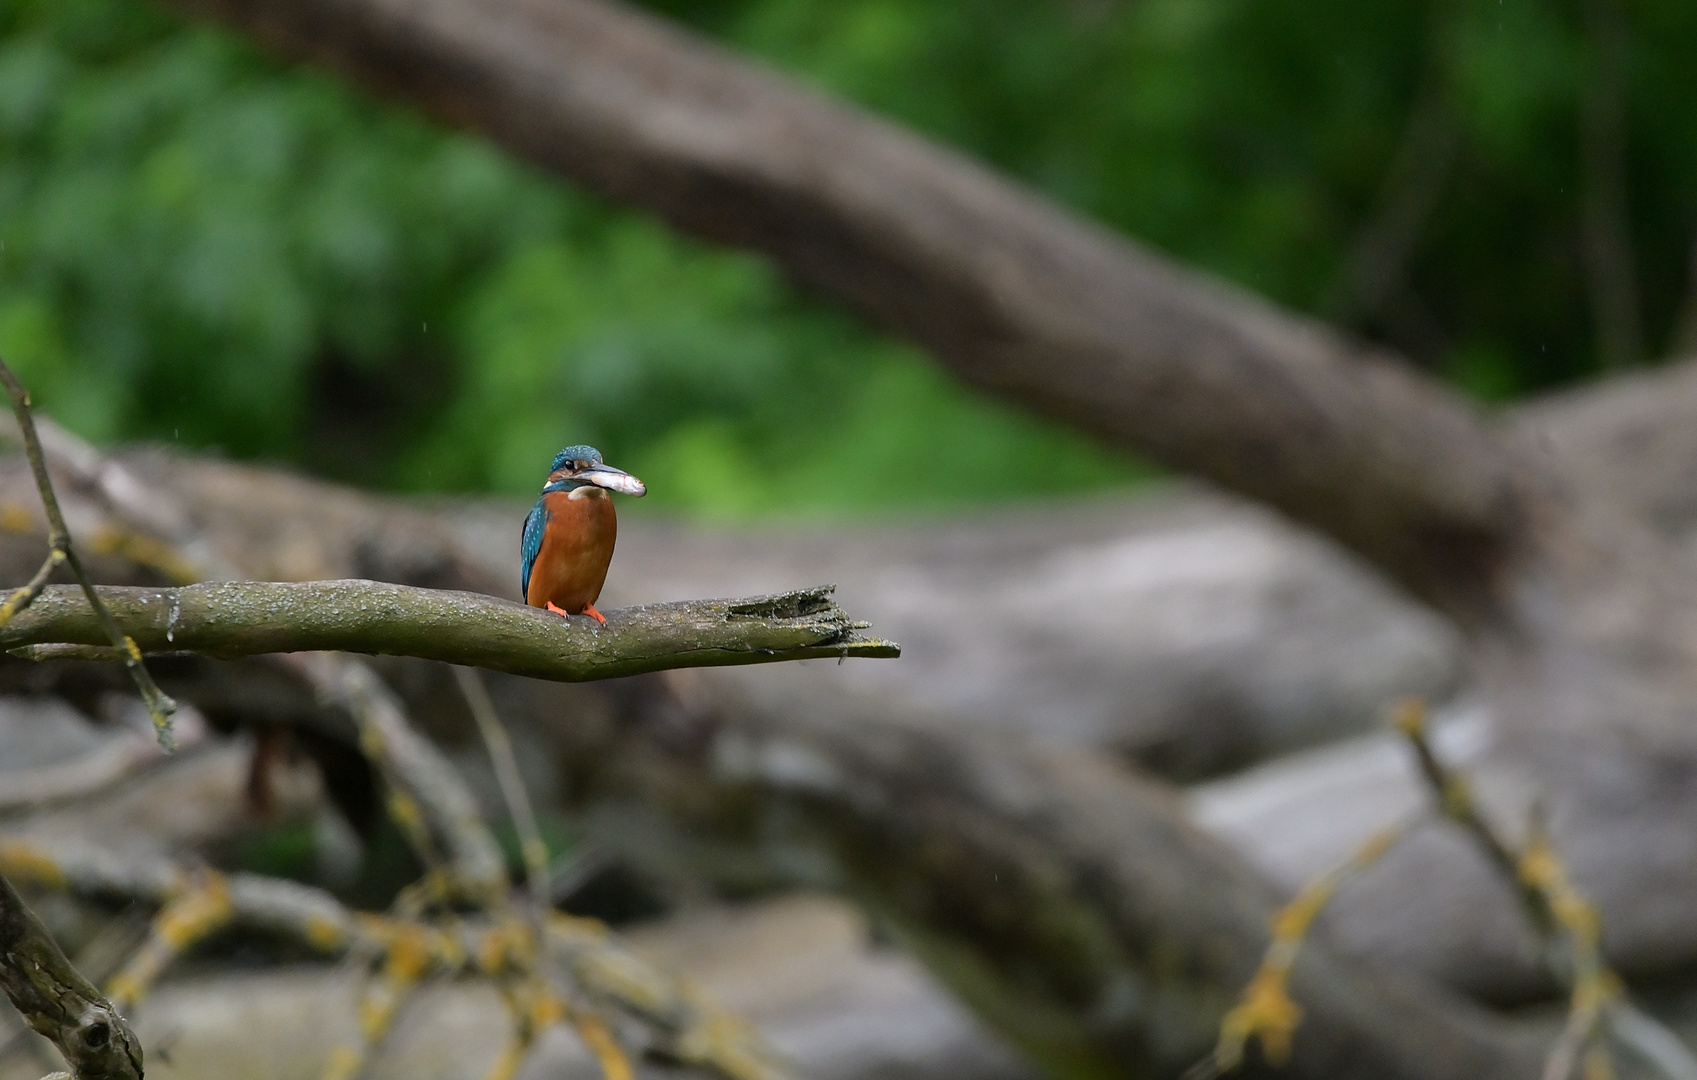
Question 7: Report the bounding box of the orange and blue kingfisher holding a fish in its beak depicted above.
[519,447,648,627]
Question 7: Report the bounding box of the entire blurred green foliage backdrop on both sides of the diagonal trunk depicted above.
[0,0,1697,520]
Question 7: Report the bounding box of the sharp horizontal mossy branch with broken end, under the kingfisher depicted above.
[0,581,901,683]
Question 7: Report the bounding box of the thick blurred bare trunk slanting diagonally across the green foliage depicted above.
[152,0,1524,615]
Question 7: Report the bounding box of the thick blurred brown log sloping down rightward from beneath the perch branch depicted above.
[580,672,1543,1080]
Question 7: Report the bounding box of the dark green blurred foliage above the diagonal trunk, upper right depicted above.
[660,0,1697,388]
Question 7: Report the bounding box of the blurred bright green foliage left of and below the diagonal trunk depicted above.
[0,0,1137,516]
